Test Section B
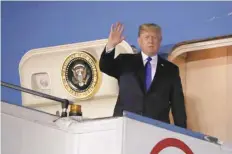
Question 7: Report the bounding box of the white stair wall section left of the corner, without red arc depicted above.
[1,103,123,154]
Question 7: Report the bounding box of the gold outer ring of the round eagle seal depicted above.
[61,50,102,100]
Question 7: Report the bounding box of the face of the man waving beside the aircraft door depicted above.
[138,30,161,56]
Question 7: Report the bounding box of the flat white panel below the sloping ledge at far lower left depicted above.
[1,114,77,154]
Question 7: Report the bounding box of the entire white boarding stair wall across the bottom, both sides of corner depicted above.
[1,103,232,154]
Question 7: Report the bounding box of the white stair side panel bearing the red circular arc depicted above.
[123,119,229,154]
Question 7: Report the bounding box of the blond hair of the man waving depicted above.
[138,23,162,38]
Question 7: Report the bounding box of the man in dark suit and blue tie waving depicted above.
[100,23,187,128]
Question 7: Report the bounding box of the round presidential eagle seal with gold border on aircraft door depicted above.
[61,51,101,100]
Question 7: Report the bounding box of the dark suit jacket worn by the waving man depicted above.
[99,49,187,128]
